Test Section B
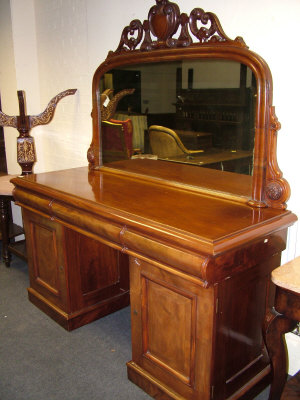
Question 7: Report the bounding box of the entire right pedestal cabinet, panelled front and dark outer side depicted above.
[127,239,285,400]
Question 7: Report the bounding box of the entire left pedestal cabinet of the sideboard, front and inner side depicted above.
[23,210,129,330]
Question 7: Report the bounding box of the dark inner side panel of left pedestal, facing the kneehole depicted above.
[65,229,129,312]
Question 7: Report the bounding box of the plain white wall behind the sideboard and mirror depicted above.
[0,0,300,258]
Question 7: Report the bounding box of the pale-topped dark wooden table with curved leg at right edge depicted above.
[264,257,300,400]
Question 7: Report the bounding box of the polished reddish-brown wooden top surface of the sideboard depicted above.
[13,163,296,252]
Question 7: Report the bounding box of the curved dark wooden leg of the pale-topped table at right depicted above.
[264,309,296,400]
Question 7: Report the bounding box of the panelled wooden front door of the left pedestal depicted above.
[23,210,69,310]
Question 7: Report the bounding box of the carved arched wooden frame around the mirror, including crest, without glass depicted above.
[87,0,290,209]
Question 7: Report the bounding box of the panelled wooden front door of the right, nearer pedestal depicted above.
[128,258,215,399]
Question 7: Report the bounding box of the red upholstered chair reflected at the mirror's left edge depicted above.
[101,119,133,164]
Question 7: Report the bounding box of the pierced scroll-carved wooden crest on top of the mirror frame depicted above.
[113,0,247,55]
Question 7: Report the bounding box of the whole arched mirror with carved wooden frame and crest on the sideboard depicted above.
[88,0,289,208]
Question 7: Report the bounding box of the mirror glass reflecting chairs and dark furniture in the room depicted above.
[100,60,256,175]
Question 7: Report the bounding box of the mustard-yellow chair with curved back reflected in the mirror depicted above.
[149,125,203,158]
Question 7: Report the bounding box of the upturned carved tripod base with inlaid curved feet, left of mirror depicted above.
[0,89,77,175]
